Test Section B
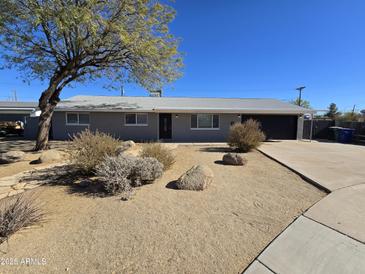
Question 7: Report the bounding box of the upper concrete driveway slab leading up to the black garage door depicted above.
[260,141,365,191]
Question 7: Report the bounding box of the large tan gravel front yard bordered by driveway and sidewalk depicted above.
[0,146,325,273]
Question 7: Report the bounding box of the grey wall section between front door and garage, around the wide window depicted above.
[172,113,241,142]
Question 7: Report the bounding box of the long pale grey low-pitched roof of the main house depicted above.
[56,95,315,114]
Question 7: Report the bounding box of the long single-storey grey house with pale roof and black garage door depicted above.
[46,96,313,142]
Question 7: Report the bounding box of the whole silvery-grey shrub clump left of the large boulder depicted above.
[96,154,163,197]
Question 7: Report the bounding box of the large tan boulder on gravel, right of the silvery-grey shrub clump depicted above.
[176,165,214,190]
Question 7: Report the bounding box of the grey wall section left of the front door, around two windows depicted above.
[52,112,158,141]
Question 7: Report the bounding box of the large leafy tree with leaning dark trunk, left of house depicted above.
[0,0,182,150]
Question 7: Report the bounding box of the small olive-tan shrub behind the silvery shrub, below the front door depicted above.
[140,143,175,170]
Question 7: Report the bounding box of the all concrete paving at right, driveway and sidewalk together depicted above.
[244,141,365,274]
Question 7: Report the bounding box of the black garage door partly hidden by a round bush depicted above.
[241,115,298,139]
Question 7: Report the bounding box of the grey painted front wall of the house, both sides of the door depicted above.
[52,112,303,142]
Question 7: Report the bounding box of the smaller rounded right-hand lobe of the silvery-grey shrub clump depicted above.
[130,157,164,186]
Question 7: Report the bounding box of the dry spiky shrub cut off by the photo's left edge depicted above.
[0,195,44,244]
